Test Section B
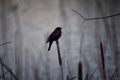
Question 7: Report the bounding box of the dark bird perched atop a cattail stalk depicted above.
[46,27,62,51]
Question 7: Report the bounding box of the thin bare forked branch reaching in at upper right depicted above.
[72,9,120,22]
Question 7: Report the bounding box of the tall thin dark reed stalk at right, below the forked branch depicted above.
[100,41,107,80]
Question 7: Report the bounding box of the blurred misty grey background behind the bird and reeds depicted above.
[0,0,120,80]
